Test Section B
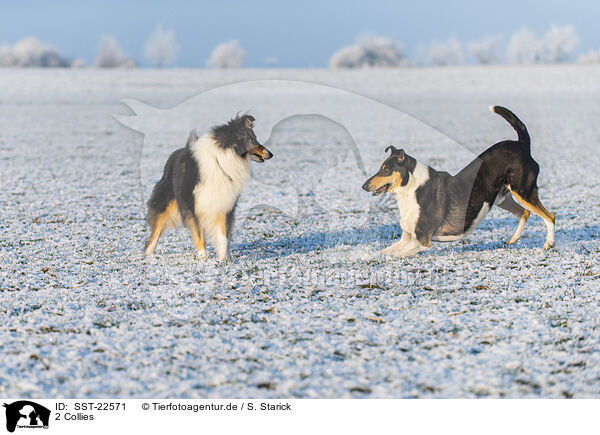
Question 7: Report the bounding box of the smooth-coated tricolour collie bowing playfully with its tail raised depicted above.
[363,106,555,257]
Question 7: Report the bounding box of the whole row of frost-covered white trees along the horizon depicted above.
[0,25,600,68]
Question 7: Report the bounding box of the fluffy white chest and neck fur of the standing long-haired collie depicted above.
[192,135,250,216]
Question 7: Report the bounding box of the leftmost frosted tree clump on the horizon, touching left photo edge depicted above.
[0,38,70,68]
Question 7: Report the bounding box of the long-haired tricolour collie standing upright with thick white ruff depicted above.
[146,115,273,260]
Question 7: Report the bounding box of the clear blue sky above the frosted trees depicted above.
[0,0,600,67]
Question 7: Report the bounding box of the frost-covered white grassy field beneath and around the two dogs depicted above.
[0,66,600,398]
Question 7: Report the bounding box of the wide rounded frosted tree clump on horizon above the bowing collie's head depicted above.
[329,35,407,68]
